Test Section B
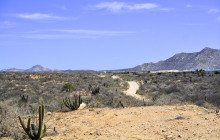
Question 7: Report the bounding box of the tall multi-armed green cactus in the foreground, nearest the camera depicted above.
[18,105,47,140]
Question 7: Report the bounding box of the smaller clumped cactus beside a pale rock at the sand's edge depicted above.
[63,95,82,110]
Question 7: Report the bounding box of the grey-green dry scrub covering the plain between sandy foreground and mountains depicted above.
[0,70,220,139]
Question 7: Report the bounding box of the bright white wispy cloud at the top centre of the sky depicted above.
[95,2,159,12]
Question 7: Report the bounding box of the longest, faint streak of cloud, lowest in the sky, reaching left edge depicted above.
[0,29,134,39]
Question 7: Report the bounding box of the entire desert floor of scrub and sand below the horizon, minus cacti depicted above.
[1,69,220,140]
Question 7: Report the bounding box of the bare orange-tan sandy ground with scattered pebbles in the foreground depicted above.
[43,105,220,140]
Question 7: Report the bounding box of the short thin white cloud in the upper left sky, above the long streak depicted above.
[15,13,69,20]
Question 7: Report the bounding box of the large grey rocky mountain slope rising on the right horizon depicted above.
[128,47,220,71]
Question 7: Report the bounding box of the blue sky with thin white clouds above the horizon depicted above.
[0,0,220,70]
